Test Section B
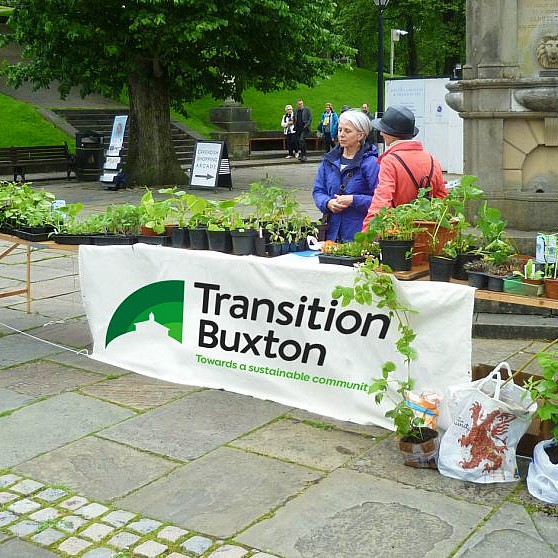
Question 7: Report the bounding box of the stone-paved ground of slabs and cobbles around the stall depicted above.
[0,171,558,558]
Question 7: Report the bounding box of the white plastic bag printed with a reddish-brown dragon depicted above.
[438,362,537,483]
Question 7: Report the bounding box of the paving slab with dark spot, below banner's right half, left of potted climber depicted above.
[230,420,374,471]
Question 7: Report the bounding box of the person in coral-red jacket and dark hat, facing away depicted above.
[362,106,448,231]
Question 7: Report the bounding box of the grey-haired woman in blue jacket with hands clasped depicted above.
[312,110,380,242]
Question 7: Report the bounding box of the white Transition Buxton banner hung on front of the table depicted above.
[79,244,474,428]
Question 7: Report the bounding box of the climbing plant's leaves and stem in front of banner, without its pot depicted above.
[332,257,423,439]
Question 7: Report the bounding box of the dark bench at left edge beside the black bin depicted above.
[0,143,75,182]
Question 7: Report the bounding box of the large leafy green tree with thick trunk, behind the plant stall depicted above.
[2,0,350,185]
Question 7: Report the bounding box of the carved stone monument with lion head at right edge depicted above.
[446,0,558,231]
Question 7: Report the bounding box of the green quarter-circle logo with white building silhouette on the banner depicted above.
[105,281,184,347]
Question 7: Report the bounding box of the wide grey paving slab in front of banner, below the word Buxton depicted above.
[99,390,289,461]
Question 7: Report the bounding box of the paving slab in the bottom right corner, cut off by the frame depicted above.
[455,504,556,558]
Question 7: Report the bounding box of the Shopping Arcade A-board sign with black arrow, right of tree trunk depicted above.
[190,141,232,190]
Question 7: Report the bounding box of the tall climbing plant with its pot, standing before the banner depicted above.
[332,257,439,468]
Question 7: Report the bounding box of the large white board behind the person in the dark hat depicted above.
[385,78,463,174]
